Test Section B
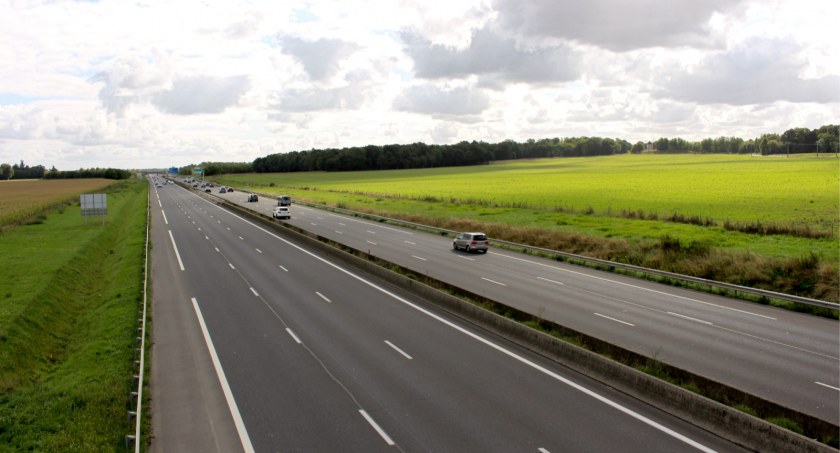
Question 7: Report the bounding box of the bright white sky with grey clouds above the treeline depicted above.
[0,0,840,170]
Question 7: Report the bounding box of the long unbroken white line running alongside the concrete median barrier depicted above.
[190,189,715,453]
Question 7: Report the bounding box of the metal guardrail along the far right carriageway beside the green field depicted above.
[295,201,840,310]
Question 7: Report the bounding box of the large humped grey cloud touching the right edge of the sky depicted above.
[655,38,840,105]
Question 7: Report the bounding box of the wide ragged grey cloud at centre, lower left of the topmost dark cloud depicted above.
[402,29,580,83]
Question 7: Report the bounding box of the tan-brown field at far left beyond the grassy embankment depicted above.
[0,179,116,227]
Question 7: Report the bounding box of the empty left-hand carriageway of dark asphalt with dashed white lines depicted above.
[146,180,741,453]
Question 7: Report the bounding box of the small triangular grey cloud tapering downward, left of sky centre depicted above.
[279,36,358,80]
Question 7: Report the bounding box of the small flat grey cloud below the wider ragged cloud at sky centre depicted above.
[393,85,490,115]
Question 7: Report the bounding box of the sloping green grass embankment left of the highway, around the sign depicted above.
[0,180,148,451]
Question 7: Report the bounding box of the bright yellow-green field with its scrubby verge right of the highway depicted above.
[215,155,840,302]
